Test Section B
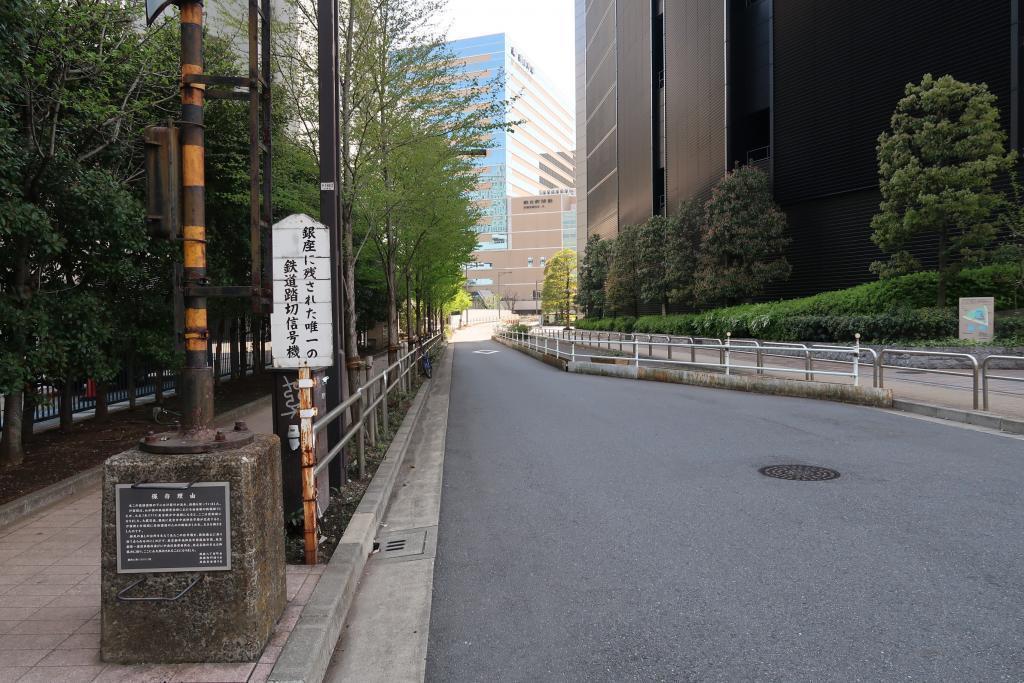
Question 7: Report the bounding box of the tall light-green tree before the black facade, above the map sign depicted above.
[871,74,1015,306]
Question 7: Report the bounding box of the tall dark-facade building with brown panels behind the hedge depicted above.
[577,0,1022,296]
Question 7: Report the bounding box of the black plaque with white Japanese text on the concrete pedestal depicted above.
[115,481,231,573]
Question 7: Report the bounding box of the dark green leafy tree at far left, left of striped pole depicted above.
[0,0,179,466]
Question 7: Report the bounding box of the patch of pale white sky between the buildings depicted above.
[438,0,575,112]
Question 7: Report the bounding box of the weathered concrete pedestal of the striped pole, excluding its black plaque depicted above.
[101,434,286,664]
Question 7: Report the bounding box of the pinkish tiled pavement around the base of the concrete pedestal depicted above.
[0,486,324,683]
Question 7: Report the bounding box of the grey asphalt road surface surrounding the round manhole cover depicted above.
[427,333,1024,681]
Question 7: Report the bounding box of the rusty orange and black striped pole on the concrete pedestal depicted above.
[180,0,213,432]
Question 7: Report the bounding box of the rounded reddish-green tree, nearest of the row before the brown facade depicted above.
[694,166,791,304]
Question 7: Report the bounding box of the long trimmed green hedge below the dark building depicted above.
[577,265,1024,342]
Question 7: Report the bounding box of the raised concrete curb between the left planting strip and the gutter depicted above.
[269,358,438,683]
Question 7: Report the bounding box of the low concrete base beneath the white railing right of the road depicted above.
[494,338,893,408]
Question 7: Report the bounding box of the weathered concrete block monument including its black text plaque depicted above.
[101,432,286,664]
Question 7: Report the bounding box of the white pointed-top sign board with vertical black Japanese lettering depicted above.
[270,214,334,368]
